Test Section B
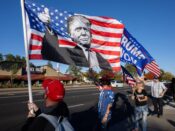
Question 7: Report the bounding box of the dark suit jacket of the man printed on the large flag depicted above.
[41,31,112,70]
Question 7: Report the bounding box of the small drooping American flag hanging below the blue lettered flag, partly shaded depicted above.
[121,66,136,87]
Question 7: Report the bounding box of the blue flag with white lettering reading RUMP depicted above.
[121,28,154,76]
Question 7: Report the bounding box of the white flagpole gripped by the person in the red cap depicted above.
[21,0,33,103]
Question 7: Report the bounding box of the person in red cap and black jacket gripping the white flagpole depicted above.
[21,79,73,131]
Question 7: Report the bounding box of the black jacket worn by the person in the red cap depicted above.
[21,102,69,131]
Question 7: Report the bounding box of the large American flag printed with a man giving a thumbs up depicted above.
[25,1,124,71]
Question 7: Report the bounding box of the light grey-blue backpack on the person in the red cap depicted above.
[39,113,74,131]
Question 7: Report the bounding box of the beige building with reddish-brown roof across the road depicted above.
[0,65,76,87]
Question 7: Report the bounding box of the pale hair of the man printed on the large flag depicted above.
[67,15,91,34]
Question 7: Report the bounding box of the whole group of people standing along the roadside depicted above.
[21,77,174,131]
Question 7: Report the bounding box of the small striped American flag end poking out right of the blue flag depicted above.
[145,60,161,77]
